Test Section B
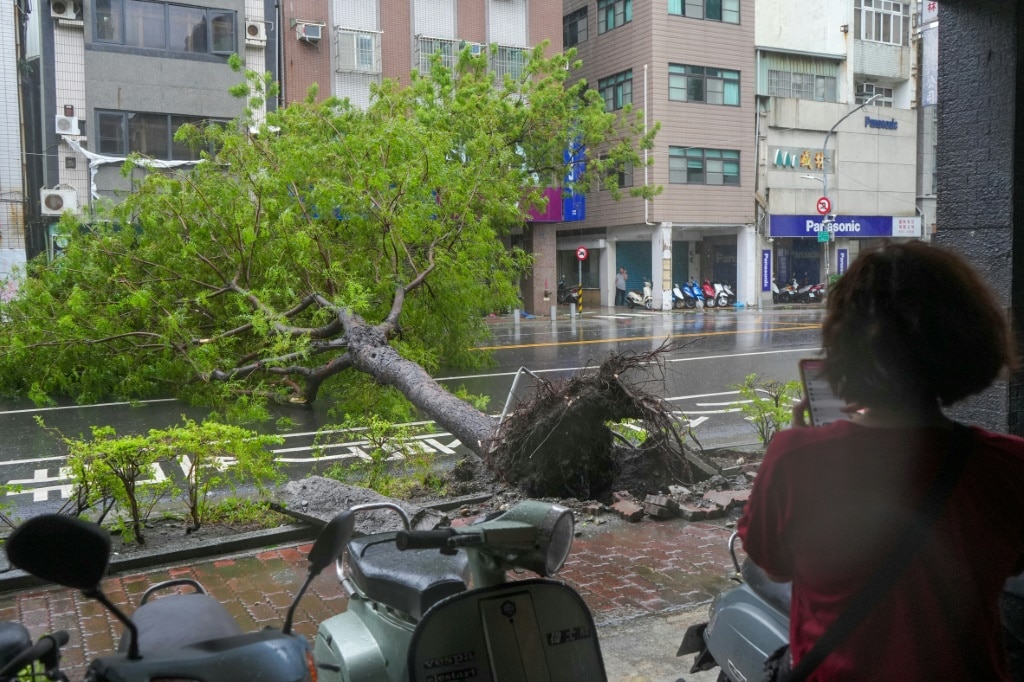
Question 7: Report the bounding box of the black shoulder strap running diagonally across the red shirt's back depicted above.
[782,424,973,682]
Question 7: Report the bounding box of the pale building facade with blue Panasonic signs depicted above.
[756,0,934,300]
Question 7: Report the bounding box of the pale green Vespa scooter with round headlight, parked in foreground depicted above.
[313,501,607,682]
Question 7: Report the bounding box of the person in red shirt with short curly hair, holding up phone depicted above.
[737,242,1024,682]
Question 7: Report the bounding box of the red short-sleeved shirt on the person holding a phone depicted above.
[738,421,1024,682]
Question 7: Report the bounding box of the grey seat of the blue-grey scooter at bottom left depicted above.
[118,593,242,655]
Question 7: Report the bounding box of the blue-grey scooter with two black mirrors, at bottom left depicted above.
[0,514,352,682]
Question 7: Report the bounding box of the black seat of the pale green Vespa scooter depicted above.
[348,532,469,621]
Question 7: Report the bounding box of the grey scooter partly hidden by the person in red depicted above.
[676,532,793,682]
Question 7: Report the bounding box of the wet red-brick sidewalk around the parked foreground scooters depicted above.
[0,515,731,682]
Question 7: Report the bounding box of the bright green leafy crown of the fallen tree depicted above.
[0,46,657,411]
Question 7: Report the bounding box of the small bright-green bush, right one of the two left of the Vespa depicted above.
[147,419,284,530]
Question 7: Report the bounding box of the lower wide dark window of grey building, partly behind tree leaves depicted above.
[96,112,225,161]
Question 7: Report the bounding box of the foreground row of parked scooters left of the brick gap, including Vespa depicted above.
[0,501,606,682]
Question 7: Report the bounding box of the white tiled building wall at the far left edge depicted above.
[0,0,25,274]
